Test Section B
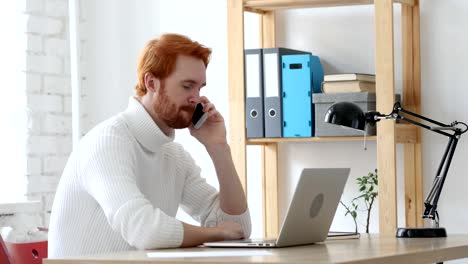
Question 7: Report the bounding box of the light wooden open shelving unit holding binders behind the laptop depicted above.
[227,0,423,237]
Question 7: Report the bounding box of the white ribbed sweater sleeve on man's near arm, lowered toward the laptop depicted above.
[79,129,183,249]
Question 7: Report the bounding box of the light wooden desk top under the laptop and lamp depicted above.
[43,235,468,264]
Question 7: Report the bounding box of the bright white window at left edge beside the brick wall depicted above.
[0,1,27,202]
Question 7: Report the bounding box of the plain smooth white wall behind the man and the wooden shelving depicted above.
[82,0,468,243]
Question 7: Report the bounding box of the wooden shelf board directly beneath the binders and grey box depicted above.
[246,124,418,145]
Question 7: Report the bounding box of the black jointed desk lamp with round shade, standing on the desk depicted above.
[324,102,468,237]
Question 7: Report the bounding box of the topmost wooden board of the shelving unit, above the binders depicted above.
[244,0,415,13]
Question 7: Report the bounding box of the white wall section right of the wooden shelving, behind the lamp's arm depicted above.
[421,0,468,233]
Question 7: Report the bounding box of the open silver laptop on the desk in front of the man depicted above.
[203,168,350,247]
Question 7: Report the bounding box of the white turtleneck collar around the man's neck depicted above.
[122,96,174,152]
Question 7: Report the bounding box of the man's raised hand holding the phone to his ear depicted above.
[189,96,227,148]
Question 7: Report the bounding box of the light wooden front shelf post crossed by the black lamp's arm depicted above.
[374,0,397,234]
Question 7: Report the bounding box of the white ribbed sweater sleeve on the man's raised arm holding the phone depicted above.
[181,152,251,238]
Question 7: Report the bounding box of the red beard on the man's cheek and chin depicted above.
[154,81,195,129]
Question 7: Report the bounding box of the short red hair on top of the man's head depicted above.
[135,34,211,96]
